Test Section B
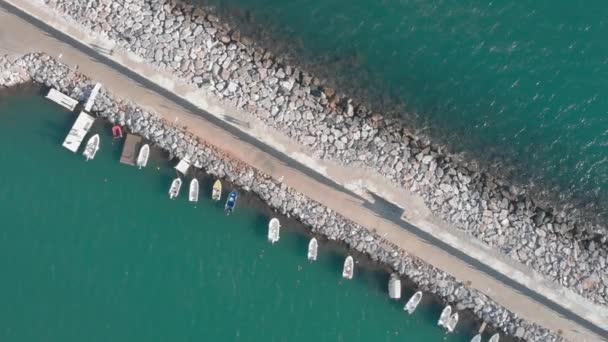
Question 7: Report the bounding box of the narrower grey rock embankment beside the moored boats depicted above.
[0,54,563,341]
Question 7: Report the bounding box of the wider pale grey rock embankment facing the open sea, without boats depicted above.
[38,0,608,305]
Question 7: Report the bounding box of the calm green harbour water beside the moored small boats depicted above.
[0,89,478,342]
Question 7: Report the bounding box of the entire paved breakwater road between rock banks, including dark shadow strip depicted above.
[0,1,608,341]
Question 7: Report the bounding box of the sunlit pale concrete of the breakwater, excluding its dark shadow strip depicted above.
[0,0,608,341]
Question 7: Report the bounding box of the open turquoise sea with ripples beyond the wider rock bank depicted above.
[194,0,608,214]
